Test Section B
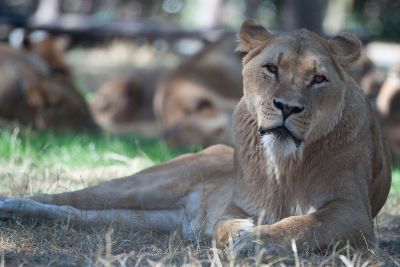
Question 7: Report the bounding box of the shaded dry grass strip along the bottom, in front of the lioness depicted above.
[0,214,400,266]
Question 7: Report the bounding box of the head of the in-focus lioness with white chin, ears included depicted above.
[239,22,360,159]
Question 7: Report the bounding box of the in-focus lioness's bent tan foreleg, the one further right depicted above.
[234,202,375,254]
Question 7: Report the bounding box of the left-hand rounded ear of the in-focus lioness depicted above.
[236,20,272,54]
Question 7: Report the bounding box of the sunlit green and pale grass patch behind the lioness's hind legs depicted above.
[0,128,198,195]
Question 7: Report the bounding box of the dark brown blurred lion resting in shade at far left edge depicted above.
[0,37,96,130]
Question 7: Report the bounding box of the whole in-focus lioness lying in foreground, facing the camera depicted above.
[0,21,391,255]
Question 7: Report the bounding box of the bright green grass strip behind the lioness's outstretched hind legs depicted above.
[0,128,198,167]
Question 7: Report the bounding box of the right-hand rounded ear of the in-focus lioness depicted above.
[329,32,362,68]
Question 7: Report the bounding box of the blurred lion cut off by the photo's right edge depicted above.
[376,64,400,165]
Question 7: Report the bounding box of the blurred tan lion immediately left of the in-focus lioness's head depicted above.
[153,36,243,146]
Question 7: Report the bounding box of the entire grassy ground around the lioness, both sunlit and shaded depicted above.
[0,130,400,267]
